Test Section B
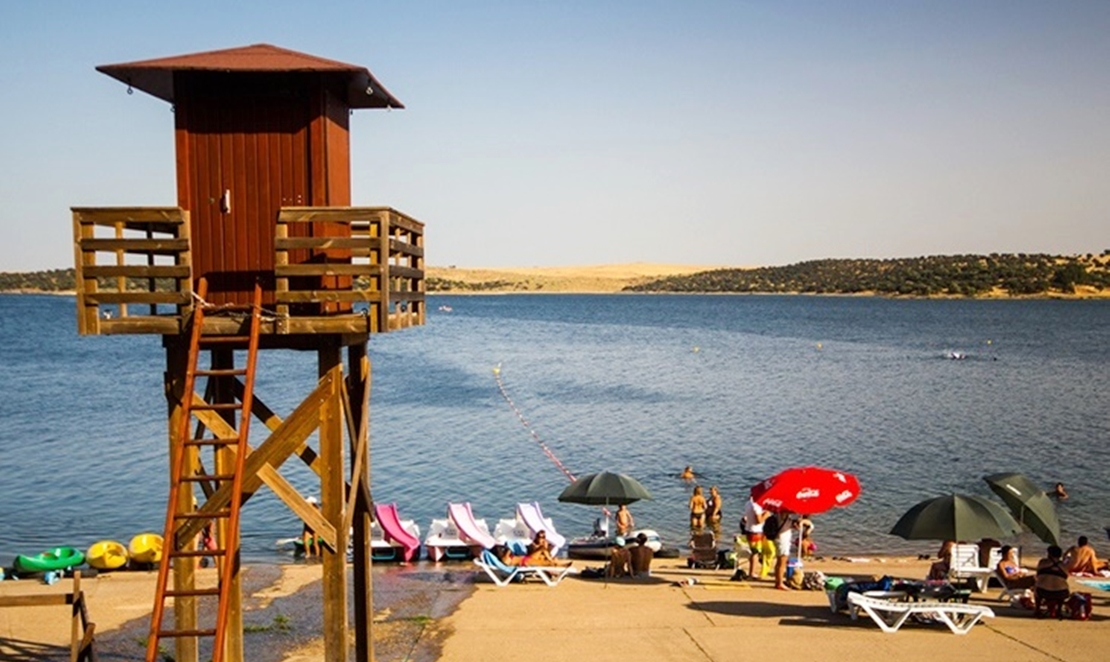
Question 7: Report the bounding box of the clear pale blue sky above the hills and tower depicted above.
[0,0,1110,271]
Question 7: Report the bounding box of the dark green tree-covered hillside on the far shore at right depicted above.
[625,251,1110,297]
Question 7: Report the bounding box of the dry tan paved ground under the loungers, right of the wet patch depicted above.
[442,560,1110,662]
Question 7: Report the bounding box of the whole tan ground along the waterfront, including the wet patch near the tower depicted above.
[0,558,1110,662]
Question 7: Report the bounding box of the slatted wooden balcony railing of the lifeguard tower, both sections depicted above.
[72,207,425,335]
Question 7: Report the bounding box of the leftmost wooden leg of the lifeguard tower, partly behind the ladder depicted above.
[162,335,199,662]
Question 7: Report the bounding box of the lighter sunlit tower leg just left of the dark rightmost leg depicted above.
[319,343,347,662]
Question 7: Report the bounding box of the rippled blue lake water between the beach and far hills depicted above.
[0,294,1110,565]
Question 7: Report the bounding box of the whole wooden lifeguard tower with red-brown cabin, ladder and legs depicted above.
[72,44,425,662]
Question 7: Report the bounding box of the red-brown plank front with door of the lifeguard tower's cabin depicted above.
[175,72,312,303]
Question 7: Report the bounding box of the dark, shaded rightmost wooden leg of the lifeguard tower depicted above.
[347,342,374,662]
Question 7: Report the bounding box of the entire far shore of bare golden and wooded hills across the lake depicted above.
[8,251,1110,297]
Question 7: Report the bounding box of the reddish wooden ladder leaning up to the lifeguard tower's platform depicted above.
[147,278,262,662]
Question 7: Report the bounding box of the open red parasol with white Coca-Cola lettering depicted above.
[751,467,859,514]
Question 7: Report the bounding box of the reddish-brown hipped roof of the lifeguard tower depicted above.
[97,43,404,108]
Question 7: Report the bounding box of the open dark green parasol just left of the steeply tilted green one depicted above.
[890,494,1021,540]
